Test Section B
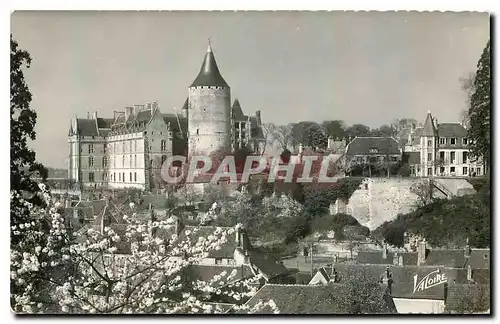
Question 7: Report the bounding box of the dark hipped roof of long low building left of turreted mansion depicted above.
[346,137,400,155]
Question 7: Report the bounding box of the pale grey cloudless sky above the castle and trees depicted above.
[11,11,490,168]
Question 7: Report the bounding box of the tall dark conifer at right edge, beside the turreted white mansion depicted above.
[468,40,491,171]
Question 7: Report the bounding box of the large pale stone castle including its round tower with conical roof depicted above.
[68,42,265,190]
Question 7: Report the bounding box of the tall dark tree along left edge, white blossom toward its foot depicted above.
[10,35,57,312]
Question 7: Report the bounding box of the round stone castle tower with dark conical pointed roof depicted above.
[187,41,231,155]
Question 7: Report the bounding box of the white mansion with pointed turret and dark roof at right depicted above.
[404,111,484,177]
